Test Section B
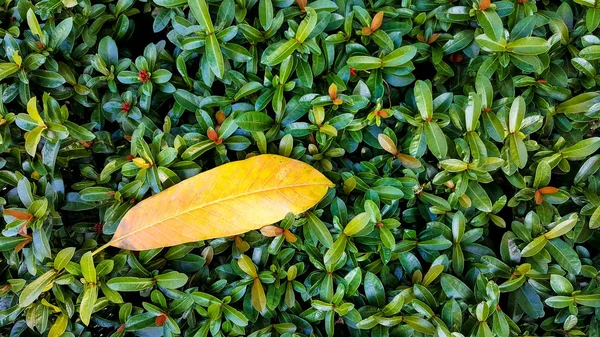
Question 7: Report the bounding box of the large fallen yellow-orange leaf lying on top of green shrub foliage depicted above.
[108,155,334,250]
